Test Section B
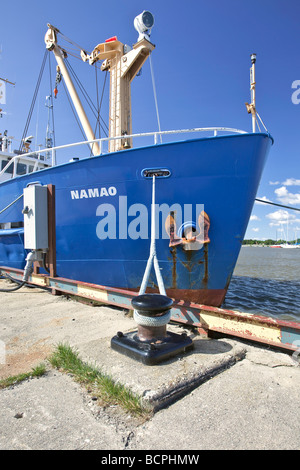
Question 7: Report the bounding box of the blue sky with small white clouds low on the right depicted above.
[0,0,300,239]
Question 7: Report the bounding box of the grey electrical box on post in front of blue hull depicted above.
[23,185,48,250]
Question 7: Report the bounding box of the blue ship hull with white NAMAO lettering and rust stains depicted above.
[0,134,272,306]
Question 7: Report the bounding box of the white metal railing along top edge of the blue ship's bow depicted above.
[0,127,248,177]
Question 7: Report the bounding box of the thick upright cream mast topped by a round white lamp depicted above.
[81,11,155,152]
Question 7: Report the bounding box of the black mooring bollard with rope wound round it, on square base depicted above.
[111,294,194,365]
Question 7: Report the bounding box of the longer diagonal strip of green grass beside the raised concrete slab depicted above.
[49,344,150,419]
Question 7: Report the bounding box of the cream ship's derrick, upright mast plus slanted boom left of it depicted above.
[45,11,155,155]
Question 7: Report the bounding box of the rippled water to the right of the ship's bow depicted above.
[222,246,300,322]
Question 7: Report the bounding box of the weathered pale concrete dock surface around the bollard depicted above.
[0,280,300,450]
